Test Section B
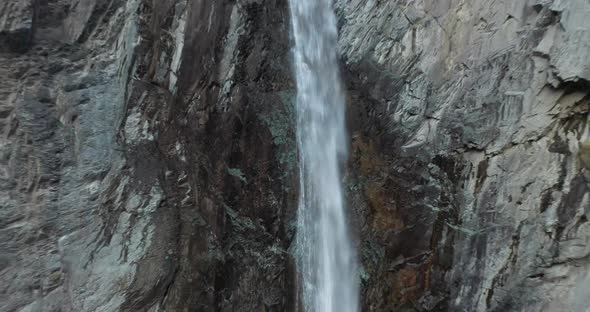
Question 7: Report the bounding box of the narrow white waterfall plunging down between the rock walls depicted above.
[290,0,358,312]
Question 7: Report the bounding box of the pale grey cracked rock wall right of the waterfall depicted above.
[337,0,590,311]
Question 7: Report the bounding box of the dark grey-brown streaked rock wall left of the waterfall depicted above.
[0,0,297,311]
